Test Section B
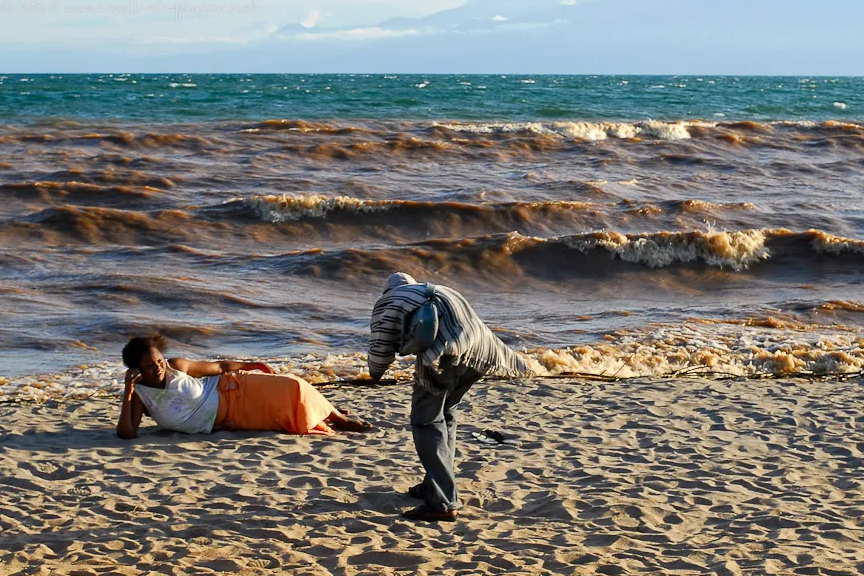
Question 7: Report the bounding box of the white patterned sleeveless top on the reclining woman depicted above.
[135,368,219,434]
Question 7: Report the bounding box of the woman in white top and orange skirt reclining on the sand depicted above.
[117,334,372,439]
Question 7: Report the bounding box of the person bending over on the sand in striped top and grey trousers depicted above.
[369,272,528,522]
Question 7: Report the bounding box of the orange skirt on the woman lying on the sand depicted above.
[213,372,334,434]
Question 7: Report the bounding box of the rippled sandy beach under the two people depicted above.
[0,379,864,576]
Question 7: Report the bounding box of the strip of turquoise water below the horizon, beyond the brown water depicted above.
[0,74,864,123]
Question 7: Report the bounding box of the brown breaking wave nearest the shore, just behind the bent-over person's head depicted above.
[256,229,864,279]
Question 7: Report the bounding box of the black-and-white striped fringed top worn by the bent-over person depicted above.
[368,284,528,393]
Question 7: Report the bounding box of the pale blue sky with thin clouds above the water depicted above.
[0,0,864,76]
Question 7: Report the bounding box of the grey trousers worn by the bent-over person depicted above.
[411,366,484,511]
